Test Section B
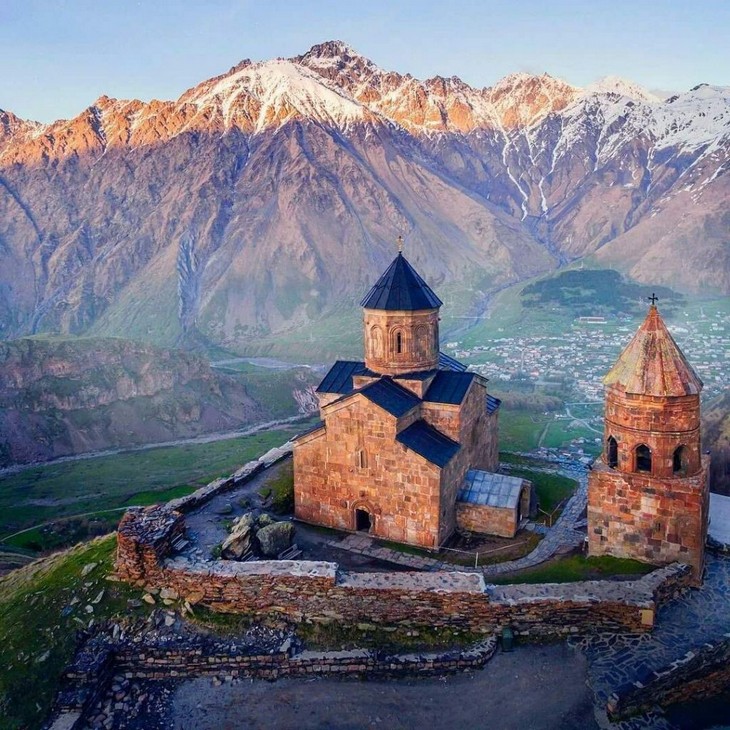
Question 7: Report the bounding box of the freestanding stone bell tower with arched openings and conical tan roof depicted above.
[588,297,709,583]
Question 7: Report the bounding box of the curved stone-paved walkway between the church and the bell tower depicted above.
[329,465,588,578]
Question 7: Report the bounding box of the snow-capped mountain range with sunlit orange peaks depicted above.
[0,41,730,346]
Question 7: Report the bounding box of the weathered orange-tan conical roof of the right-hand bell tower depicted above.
[603,305,702,396]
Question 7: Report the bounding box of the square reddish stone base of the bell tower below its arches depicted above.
[588,457,709,581]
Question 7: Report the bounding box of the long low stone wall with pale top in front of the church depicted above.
[117,508,690,637]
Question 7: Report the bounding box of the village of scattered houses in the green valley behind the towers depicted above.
[444,301,730,463]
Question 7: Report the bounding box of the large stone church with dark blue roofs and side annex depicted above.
[294,247,534,549]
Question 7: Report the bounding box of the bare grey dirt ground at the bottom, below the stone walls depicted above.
[170,644,599,730]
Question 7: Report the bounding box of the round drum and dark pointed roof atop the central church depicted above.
[360,237,442,375]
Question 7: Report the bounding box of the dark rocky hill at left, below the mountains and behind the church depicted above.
[0,339,264,467]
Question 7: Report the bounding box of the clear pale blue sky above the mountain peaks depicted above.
[0,0,730,122]
